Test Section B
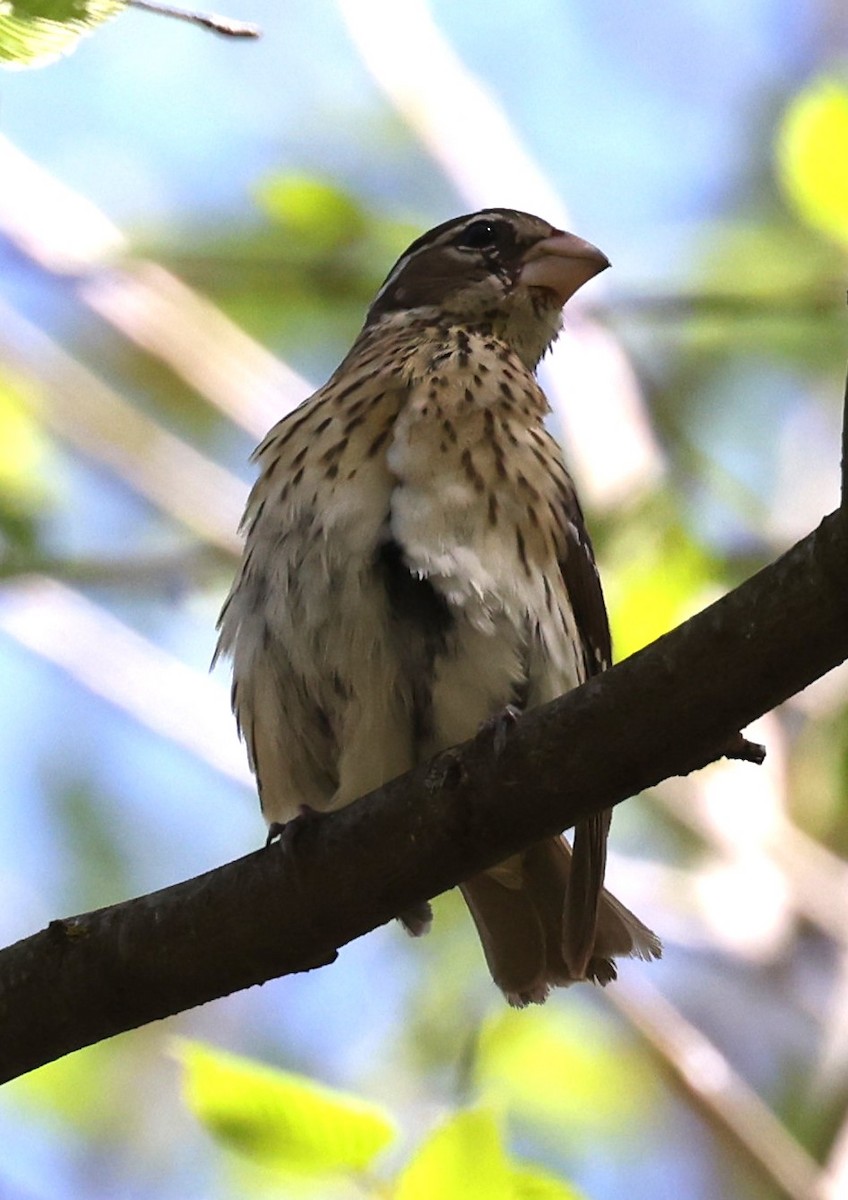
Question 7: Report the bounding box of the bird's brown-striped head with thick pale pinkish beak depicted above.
[367,209,609,367]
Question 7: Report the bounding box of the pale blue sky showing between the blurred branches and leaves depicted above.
[0,0,839,1200]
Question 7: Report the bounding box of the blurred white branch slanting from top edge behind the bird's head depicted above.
[339,0,663,506]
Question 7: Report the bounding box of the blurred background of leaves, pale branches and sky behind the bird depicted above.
[0,0,848,1200]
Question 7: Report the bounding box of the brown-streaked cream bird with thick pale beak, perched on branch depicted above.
[216,208,661,1008]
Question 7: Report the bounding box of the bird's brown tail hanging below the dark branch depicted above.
[462,838,662,1008]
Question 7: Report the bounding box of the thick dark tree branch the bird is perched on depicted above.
[0,501,848,1081]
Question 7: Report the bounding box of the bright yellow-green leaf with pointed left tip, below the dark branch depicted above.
[178,1042,396,1176]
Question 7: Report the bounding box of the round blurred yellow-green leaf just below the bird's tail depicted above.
[477,1007,650,1138]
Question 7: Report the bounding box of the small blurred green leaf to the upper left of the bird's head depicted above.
[255,173,369,252]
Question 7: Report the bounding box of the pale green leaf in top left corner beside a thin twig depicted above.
[0,0,126,67]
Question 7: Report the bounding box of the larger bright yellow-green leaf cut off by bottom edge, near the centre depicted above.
[395,1108,516,1200]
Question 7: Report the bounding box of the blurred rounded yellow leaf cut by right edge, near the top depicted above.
[777,76,848,248]
